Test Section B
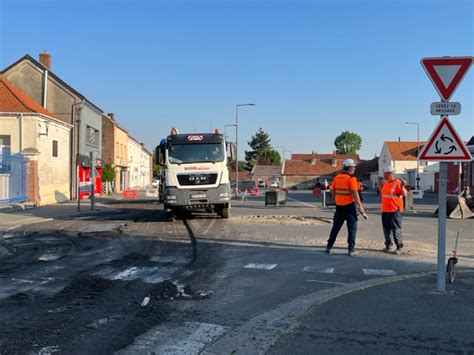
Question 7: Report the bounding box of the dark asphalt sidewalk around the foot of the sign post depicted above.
[269,272,474,354]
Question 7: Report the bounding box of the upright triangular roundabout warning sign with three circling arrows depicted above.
[418,116,472,161]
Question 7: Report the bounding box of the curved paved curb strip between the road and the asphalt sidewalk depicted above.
[201,272,433,355]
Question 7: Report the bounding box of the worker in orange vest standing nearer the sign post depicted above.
[379,166,408,254]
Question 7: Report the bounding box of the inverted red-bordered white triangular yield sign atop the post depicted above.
[421,57,472,101]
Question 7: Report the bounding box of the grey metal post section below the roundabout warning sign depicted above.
[438,162,448,292]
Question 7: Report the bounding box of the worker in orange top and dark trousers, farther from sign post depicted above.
[326,159,367,256]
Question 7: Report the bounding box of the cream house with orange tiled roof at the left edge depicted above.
[0,76,72,205]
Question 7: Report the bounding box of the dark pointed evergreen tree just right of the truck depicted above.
[245,128,281,170]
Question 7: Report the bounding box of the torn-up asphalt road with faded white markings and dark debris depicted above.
[0,192,474,354]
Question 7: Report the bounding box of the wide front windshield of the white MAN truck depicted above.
[168,143,224,164]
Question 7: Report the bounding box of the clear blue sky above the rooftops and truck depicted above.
[0,0,474,159]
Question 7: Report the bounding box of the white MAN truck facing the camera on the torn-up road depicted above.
[158,130,233,219]
